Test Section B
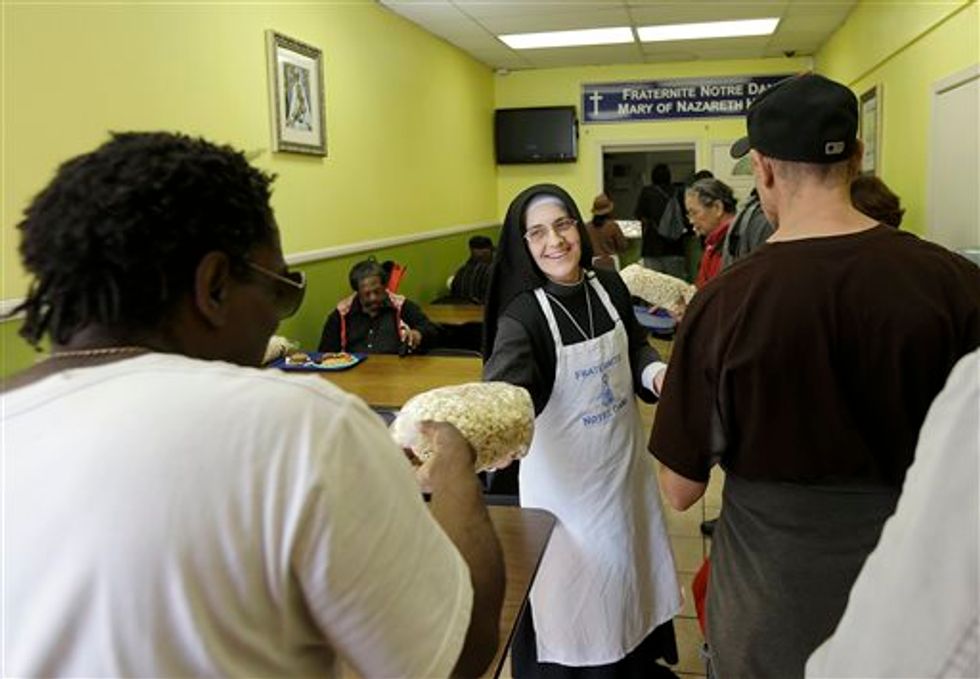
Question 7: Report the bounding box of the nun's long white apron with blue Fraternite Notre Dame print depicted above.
[520,276,681,666]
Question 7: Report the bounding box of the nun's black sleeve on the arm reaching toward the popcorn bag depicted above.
[483,316,555,416]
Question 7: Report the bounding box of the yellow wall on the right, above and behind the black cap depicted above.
[816,0,980,234]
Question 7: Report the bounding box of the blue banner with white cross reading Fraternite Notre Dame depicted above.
[582,74,791,123]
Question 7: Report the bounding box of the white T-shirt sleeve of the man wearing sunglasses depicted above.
[292,399,473,677]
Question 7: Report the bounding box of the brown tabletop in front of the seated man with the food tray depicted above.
[318,354,483,410]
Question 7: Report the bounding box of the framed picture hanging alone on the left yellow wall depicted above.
[265,30,327,156]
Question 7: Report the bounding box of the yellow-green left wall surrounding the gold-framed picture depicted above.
[0,0,497,374]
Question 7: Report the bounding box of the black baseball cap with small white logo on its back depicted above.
[731,73,858,163]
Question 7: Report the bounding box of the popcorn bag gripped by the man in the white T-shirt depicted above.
[390,382,534,472]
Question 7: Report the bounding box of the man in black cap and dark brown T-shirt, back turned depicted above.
[649,74,980,677]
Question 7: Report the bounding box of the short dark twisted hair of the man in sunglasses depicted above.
[11,132,276,347]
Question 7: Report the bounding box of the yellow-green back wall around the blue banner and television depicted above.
[494,58,811,215]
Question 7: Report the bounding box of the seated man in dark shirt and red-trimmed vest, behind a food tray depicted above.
[320,259,439,354]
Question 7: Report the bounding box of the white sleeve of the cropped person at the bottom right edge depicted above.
[806,351,980,677]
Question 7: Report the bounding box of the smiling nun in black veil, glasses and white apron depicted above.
[483,184,681,679]
